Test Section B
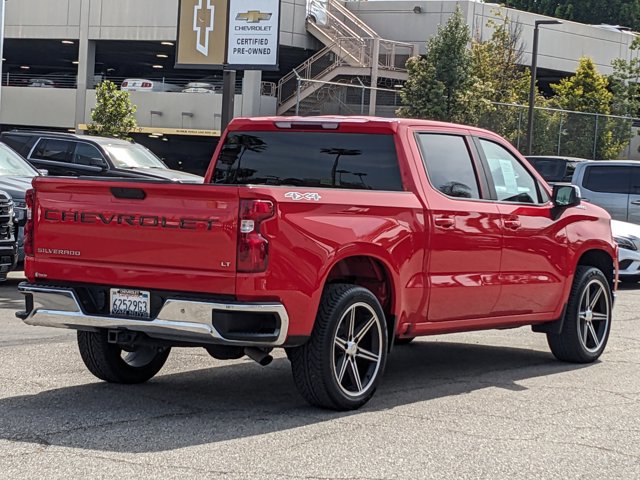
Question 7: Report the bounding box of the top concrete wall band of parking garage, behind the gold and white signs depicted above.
[6,0,315,48]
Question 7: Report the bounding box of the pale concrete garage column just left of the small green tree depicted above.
[74,0,96,134]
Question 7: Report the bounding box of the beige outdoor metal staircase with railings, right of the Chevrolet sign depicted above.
[277,0,417,115]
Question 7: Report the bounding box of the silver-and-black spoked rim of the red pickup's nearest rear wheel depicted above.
[332,302,383,397]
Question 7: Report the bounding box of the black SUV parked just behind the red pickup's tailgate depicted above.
[0,130,203,183]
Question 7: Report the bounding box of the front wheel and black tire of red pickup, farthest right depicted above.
[547,266,613,363]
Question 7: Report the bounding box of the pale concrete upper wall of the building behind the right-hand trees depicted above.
[346,0,634,74]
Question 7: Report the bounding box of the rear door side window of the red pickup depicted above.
[417,133,480,199]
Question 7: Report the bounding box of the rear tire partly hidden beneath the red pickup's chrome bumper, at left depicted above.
[78,330,171,384]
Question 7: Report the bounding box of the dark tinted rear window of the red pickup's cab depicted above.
[212,131,403,191]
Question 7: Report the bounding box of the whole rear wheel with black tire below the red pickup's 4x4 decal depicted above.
[289,284,388,411]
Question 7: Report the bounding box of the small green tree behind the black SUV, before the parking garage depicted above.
[88,80,137,140]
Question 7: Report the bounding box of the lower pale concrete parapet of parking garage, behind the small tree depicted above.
[0,87,276,130]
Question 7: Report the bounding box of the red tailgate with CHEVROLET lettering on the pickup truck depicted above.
[27,178,239,295]
